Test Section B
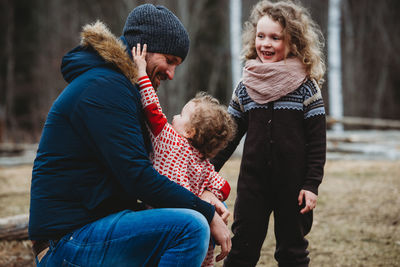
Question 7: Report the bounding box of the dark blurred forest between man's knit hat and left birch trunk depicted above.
[158,0,231,117]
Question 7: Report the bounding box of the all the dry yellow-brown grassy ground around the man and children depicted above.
[0,159,400,267]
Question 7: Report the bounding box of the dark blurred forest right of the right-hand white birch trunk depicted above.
[342,0,400,119]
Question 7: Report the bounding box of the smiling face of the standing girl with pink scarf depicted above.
[256,16,289,63]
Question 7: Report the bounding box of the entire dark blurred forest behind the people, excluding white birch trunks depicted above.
[0,0,400,143]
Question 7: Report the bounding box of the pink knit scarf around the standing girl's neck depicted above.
[243,57,307,104]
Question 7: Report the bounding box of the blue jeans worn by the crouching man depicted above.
[36,209,210,267]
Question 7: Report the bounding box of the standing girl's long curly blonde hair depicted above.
[242,0,325,85]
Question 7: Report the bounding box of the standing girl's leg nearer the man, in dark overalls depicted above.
[224,186,271,267]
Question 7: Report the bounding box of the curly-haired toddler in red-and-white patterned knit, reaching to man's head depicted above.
[132,44,236,266]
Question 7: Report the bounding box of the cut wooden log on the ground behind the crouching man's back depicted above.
[0,214,29,240]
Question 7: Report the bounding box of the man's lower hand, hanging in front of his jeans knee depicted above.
[210,212,232,261]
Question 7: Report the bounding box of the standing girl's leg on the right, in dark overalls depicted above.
[274,194,313,267]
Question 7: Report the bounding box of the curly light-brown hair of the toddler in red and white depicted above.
[188,92,236,159]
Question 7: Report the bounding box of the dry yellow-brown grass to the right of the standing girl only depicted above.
[309,161,400,266]
